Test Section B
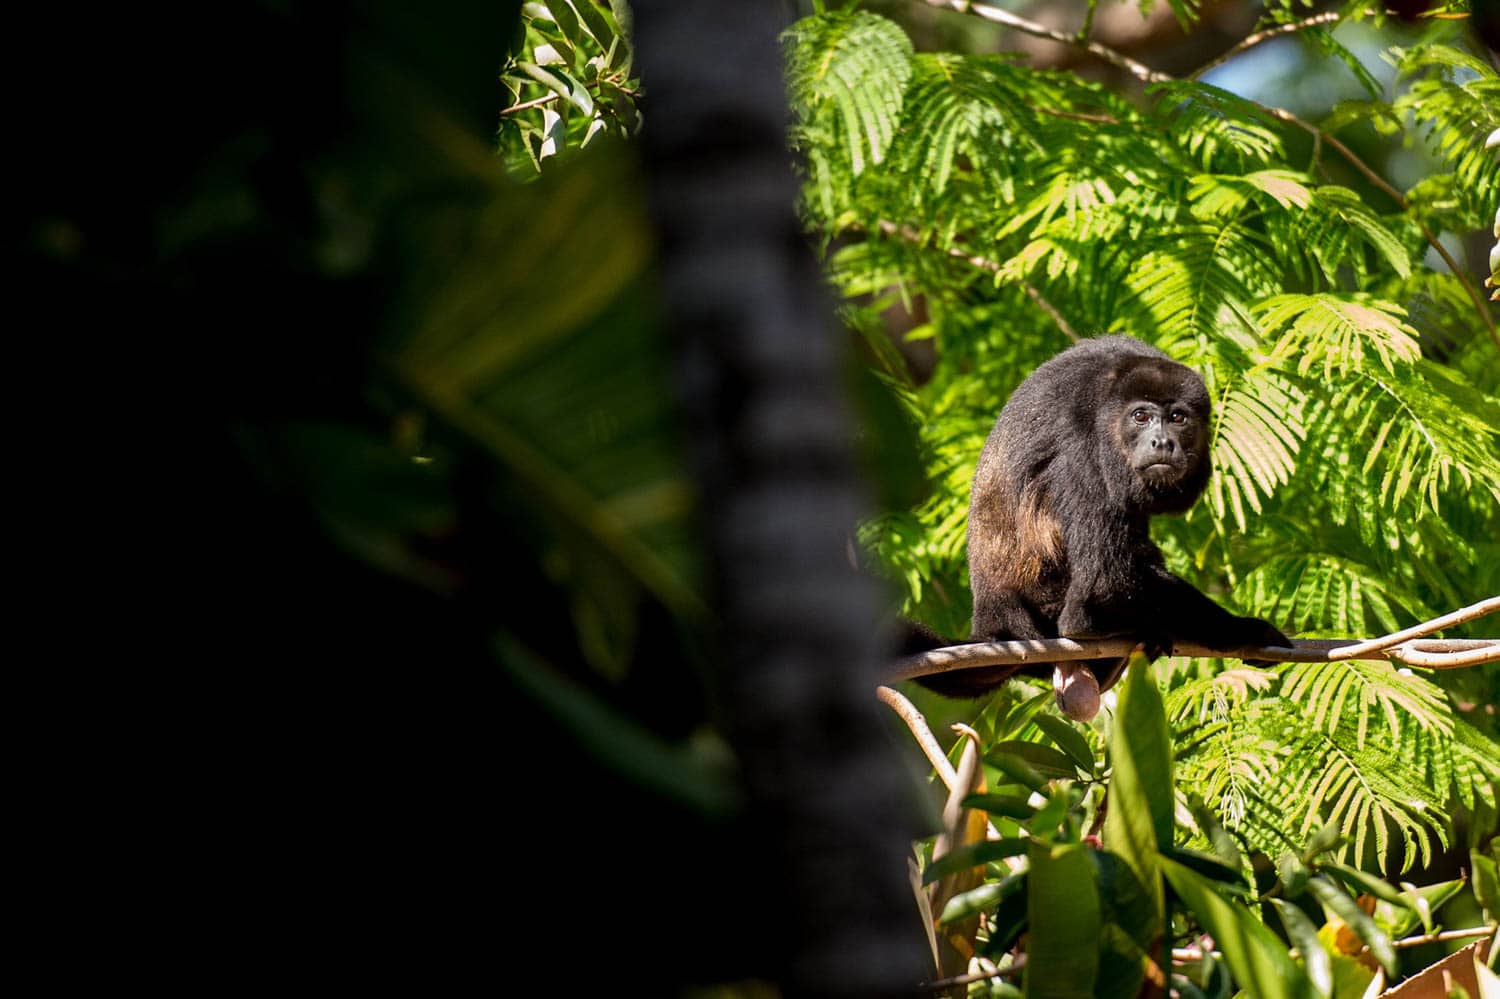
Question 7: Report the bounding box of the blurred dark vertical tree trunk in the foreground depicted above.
[633,0,929,996]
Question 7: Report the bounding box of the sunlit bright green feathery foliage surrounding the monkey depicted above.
[785,0,1500,870]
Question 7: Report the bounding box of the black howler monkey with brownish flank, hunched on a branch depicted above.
[920,336,1289,696]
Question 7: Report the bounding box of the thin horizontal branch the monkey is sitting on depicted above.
[890,638,1500,683]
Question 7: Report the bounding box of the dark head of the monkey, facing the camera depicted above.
[1101,357,1211,513]
